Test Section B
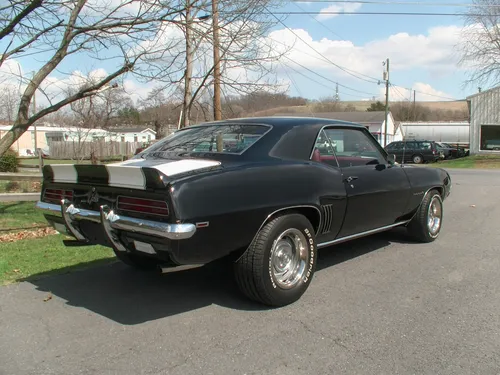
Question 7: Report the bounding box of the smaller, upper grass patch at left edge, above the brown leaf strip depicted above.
[0,202,47,232]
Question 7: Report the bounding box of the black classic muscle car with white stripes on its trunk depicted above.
[37,117,451,306]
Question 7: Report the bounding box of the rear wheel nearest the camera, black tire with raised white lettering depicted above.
[234,213,317,306]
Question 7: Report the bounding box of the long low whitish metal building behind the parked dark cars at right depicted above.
[399,121,470,147]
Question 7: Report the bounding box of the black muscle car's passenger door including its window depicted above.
[324,126,411,238]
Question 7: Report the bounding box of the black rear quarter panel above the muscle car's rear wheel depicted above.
[166,162,345,263]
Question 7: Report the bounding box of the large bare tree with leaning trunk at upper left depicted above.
[0,0,188,155]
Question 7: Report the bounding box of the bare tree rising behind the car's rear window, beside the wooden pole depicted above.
[137,0,291,126]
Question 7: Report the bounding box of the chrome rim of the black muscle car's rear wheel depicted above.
[270,228,309,289]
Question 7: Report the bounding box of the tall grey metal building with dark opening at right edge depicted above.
[467,86,500,154]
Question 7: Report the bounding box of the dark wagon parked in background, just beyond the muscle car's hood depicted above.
[385,140,441,164]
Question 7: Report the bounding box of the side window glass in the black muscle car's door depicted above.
[324,128,386,168]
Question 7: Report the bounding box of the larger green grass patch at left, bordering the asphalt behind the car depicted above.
[0,234,115,285]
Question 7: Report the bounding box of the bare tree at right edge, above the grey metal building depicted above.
[459,0,500,86]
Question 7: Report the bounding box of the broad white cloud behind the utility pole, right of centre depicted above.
[269,26,461,91]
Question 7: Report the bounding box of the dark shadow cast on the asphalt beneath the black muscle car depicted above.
[28,226,416,325]
